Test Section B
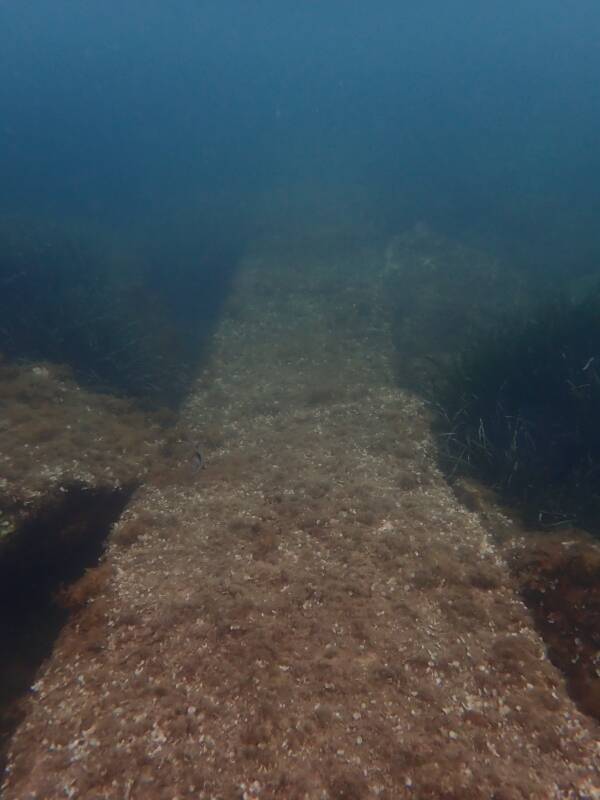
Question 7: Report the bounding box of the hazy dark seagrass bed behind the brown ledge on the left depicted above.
[0,219,239,406]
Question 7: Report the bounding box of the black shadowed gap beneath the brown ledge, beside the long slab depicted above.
[0,485,131,780]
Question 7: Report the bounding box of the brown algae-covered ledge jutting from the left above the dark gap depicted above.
[0,361,166,528]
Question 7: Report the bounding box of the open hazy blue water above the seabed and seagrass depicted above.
[0,0,600,268]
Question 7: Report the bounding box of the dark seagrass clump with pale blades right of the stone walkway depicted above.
[433,287,600,535]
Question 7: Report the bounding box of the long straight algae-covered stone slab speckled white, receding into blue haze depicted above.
[2,230,600,800]
